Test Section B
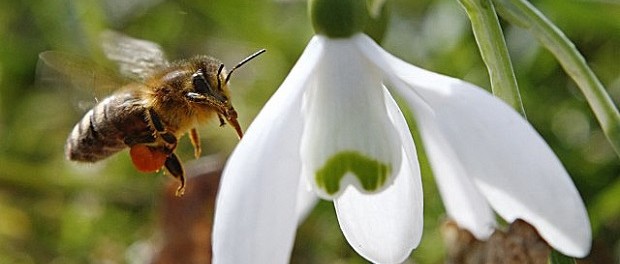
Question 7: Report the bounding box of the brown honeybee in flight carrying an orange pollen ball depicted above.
[40,31,265,196]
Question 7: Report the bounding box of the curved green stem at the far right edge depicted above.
[493,0,620,156]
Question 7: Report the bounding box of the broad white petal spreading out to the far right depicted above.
[356,34,591,257]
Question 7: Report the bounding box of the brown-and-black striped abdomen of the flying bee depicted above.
[65,91,151,162]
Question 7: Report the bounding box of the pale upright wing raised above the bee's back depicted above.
[101,30,168,81]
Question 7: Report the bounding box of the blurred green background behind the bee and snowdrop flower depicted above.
[0,0,620,264]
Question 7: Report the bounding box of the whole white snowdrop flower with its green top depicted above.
[213,0,591,263]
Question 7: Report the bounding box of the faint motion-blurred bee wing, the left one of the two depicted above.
[36,51,126,112]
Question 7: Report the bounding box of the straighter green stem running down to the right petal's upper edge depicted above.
[459,0,525,117]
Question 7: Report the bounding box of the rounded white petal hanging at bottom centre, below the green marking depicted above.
[334,90,423,263]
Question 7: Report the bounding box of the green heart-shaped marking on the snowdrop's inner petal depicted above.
[315,151,391,194]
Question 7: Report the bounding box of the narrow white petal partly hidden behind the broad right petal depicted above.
[357,35,495,239]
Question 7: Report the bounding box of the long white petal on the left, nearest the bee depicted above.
[213,36,322,263]
